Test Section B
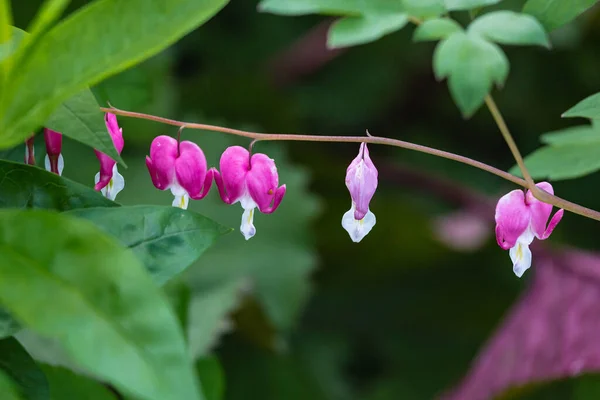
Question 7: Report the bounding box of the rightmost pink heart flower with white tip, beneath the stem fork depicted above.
[496,182,564,278]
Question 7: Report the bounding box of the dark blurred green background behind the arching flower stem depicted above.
[13,0,600,400]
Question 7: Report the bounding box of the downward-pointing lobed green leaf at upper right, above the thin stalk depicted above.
[433,32,509,117]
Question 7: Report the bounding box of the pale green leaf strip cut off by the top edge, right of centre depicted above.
[258,0,403,16]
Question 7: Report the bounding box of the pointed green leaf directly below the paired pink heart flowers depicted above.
[69,206,231,285]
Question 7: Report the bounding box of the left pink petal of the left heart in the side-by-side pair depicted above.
[146,135,177,190]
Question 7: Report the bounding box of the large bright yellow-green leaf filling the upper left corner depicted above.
[0,0,227,148]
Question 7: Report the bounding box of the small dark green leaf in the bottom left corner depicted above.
[0,338,50,400]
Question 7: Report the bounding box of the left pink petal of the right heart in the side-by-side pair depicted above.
[215,146,250,204]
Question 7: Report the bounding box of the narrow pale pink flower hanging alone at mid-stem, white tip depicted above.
[342,143,378,243]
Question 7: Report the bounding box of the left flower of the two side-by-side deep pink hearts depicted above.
[146,135,213,209]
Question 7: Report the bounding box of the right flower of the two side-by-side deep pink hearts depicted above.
[213,146,286,240]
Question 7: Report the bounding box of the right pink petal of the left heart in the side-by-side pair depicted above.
[175,141,212,200]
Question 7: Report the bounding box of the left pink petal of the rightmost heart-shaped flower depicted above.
[495,190,531,250]
